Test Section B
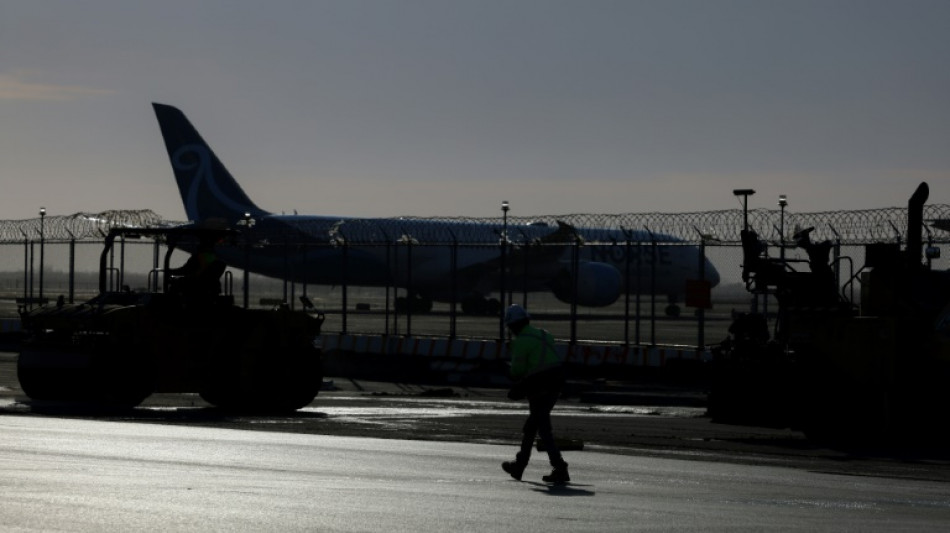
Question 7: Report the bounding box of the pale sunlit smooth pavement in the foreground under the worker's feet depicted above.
[7,416,950,533]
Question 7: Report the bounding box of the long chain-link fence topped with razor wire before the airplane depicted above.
[0,205,950,346]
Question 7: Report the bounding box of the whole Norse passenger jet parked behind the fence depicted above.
[152,103,719,316]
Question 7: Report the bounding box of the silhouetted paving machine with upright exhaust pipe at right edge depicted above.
[709,183,950,446]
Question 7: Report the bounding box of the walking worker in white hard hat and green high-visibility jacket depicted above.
[501,304,571,484]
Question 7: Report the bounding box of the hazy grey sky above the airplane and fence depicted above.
[0,0,950,220]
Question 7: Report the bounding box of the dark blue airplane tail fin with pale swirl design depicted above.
[152,103,267,224]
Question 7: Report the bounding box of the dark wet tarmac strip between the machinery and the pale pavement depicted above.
[0,352,950,482]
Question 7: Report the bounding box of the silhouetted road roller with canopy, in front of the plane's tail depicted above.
[17,226,323,412]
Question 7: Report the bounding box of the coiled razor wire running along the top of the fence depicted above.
[0,204,950,245]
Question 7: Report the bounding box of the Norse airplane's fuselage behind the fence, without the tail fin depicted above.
[205,210,719,305]
